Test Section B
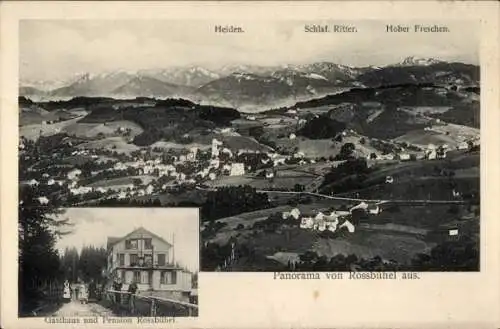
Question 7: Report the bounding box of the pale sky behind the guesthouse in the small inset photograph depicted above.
[56,208,200,272]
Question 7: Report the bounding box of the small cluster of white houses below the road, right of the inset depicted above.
[282,202,382,233]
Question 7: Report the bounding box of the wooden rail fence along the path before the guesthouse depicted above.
[105,290,198,317]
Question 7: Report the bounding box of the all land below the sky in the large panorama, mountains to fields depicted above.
[19,58,480,271]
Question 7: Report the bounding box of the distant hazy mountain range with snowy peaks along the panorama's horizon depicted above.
[19,56,479,111]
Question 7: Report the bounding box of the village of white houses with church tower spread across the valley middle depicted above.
[19,118,479,208]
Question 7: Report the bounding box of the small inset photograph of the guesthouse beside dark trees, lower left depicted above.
[19,206,199,317]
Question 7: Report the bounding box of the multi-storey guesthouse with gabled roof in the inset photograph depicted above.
[106,227,192,301]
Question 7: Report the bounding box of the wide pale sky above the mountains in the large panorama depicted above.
[19,20,479,80]
